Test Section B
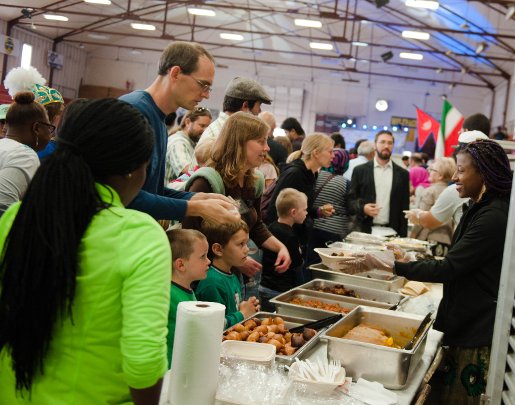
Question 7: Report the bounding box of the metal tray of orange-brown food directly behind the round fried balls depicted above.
[270,288,359,320]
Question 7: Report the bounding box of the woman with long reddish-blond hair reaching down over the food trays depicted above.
[182,112,291,277]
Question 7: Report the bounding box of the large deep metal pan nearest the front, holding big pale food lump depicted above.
[322,306,431,389]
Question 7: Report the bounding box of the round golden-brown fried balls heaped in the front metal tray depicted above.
[223,316,317,356]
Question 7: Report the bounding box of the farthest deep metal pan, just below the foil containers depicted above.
[309,263,406,292]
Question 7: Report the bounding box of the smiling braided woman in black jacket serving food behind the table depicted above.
[394,140,513,404]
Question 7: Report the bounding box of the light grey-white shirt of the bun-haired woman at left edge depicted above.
[0,138,39,215]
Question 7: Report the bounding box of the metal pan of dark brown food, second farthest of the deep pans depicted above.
[297,279,406,308]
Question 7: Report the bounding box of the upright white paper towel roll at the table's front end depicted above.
[168,301,225,405]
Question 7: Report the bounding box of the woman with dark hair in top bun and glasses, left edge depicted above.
[0,92,55,215]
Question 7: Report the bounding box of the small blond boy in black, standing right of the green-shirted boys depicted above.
[259,188,308,312]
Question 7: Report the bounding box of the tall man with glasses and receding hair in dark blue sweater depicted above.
[120,42,238,222]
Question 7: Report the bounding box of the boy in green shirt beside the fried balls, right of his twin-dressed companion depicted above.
[195,221,260,328]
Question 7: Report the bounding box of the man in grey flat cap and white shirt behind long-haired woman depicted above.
[197,77,272,145]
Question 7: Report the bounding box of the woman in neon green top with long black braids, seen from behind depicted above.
[0,99,171,405]
